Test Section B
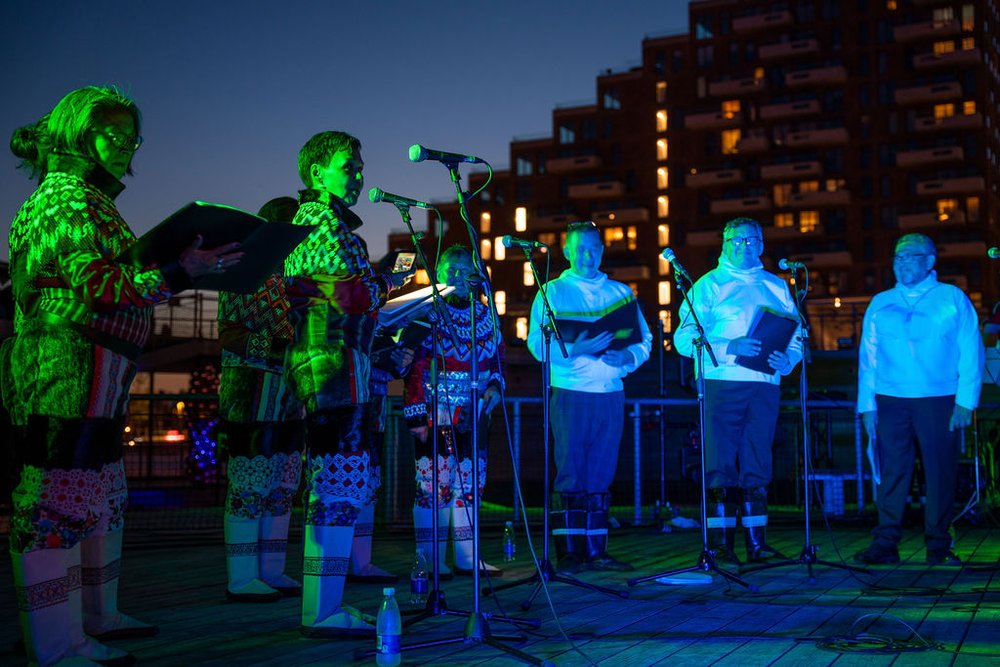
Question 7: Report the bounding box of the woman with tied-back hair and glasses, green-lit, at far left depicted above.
[2,86,242,665]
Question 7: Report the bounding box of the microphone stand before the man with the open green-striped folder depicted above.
[483,247,628,611]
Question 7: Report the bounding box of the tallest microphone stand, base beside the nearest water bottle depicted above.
[368,156,552,665]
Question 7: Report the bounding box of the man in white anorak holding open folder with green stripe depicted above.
[528,221,653,573]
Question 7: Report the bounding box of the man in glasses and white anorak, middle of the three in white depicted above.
[674,218,802,564]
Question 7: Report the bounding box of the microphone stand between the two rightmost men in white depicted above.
[740,266,871,584]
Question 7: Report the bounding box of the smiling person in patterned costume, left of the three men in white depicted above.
[403,245,505,577]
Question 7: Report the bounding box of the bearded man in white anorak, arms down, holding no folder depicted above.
[854,234,985,565]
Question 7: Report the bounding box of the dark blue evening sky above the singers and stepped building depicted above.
[0,0,688,259]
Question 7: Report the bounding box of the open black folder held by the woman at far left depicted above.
[117,201,314,294]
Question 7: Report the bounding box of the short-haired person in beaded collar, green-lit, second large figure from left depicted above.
[285,131,406,638]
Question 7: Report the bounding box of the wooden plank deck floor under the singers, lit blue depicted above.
[0,516,1000,667]
